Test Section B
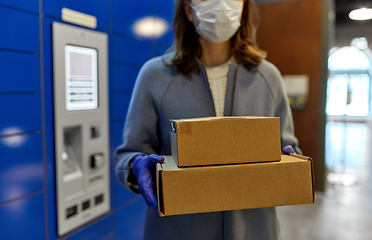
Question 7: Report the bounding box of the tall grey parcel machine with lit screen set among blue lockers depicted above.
[53,22,110,236]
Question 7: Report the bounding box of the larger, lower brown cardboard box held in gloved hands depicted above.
[156,155,314,216]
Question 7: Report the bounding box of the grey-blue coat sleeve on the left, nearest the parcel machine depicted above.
[115,59,160,191]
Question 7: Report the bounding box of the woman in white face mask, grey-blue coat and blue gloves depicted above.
[115,0,300,240]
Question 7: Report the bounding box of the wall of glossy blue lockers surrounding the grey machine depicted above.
[0,0,173,239]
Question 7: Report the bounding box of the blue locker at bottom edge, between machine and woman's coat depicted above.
[115,196,148,240]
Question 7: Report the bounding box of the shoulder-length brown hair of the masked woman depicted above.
[172,0,266,76]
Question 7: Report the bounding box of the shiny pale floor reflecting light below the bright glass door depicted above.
[277,123,372,240]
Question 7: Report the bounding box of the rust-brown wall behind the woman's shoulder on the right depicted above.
[257,0,328,190]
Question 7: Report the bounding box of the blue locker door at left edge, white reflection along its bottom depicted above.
[0,95,41,136]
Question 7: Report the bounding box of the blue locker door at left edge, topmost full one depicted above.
[0,7,40,52]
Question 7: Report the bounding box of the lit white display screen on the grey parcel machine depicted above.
[65,45,98,111]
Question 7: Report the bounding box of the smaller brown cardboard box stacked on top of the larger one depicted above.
[171,117,281,167]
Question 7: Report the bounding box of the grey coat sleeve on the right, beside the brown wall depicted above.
[262,64,302,154]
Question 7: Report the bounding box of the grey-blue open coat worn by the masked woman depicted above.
[115,53,301,240]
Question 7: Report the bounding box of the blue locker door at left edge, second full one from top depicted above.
[0,51,40,92]
